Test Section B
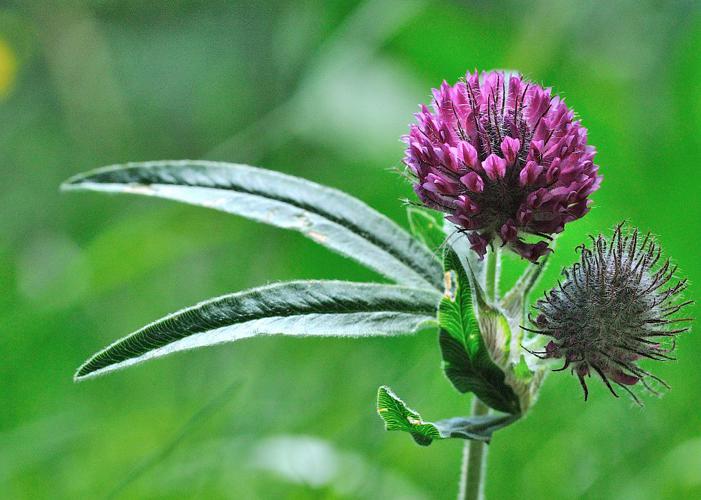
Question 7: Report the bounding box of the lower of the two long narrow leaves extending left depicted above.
[76,281,440,379]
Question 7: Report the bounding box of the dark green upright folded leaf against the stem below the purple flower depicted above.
[438,249,520,414]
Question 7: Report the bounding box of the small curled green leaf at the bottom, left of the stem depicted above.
[377,386,518,446]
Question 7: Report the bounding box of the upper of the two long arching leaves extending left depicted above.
[63,160,442,290]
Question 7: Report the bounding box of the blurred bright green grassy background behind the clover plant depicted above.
[0,0,701,500]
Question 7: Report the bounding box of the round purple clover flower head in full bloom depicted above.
[402,71,602,262]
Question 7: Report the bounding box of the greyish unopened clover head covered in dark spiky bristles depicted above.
[527,224,692,404]
